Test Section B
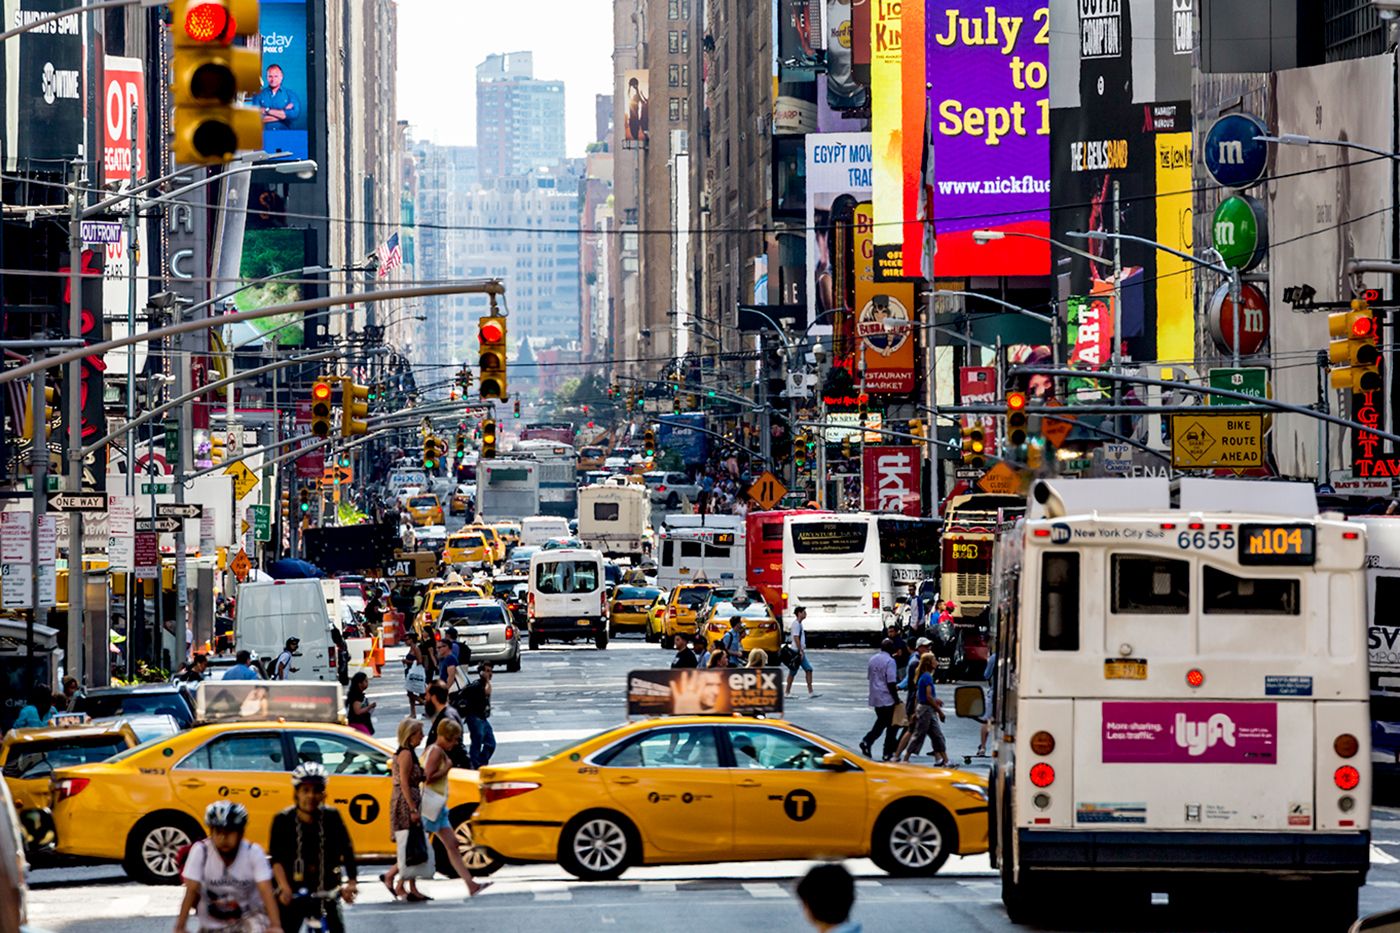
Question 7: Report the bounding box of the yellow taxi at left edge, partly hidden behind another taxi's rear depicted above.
[0,721,137,810]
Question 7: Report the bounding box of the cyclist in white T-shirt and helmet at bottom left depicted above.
[175,800,281,933]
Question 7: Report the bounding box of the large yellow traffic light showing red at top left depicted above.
[171,0,260,165]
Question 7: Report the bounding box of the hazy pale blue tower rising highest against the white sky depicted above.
[476,52,564,185]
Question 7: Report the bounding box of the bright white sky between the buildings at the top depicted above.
[399,0,613,156]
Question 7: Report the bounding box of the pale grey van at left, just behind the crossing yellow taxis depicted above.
[234,580,339,682]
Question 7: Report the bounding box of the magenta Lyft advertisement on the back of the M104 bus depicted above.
[1103,702,1278,765]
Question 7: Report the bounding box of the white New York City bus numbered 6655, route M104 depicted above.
[974,479,1372,930]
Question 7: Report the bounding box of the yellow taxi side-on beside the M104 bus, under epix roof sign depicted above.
[472,711,987,881]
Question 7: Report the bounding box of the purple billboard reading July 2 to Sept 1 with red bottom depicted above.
[924,0,1050,276]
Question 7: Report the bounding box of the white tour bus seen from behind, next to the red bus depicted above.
[783,513,888,643]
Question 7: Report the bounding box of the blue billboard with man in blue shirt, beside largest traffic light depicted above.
[257,0,315,158]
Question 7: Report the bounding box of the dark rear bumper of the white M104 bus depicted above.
[1018,829,1371,883]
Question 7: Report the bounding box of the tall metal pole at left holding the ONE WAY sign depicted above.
[65,160,85,683]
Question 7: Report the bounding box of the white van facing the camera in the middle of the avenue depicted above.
[526,548,608,650]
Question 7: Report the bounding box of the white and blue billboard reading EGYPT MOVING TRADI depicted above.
[806,133,871,324]
